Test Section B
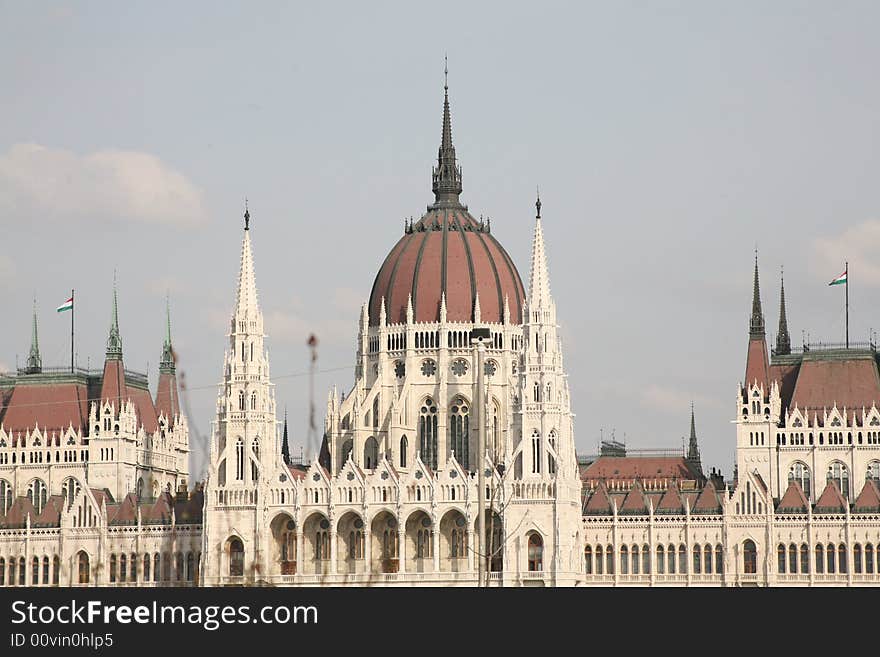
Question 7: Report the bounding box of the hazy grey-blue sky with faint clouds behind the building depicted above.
[0,1,880,476]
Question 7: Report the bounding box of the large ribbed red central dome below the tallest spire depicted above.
[369,204,525,326]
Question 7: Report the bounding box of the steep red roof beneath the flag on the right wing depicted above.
[791,357,880,411]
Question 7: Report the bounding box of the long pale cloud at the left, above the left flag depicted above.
[0,144,206,226]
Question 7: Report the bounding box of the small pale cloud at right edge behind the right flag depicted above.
[813,219,880,285]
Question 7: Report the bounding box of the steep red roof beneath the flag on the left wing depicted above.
[0,383,89,433]
